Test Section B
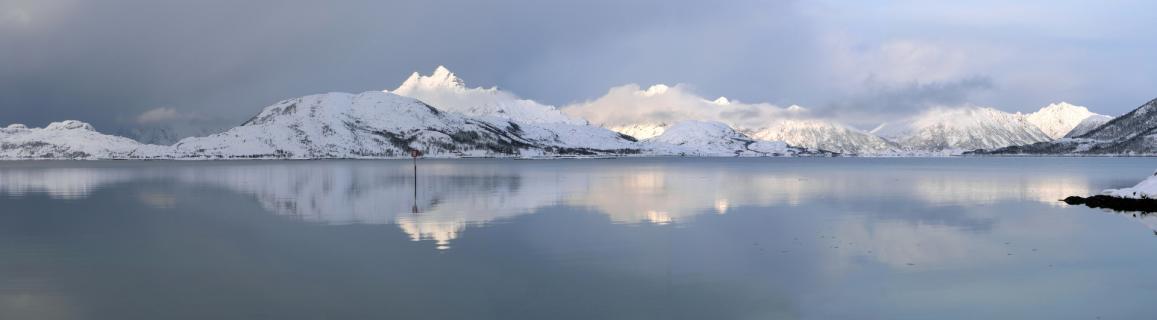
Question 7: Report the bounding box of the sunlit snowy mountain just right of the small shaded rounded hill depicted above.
[751,119,900,155]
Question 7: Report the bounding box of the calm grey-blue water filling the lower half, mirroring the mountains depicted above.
[0,158,1157,319]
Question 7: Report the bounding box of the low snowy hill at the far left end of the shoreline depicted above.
[0,120,165,159]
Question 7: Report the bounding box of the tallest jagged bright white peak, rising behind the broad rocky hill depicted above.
[390,66,587,125]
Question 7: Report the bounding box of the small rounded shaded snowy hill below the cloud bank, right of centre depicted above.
[643,120,808,156]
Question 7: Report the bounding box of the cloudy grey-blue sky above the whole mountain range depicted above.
[0,0,1157,133]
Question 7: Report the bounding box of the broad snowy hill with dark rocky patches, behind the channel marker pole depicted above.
[174,91,635,158]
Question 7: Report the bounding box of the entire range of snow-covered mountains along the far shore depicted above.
[0,67,1124,158]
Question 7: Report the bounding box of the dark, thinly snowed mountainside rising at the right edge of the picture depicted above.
[980,99,1157,155]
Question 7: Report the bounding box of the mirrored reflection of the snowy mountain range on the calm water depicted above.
[0,159,1124,249]
